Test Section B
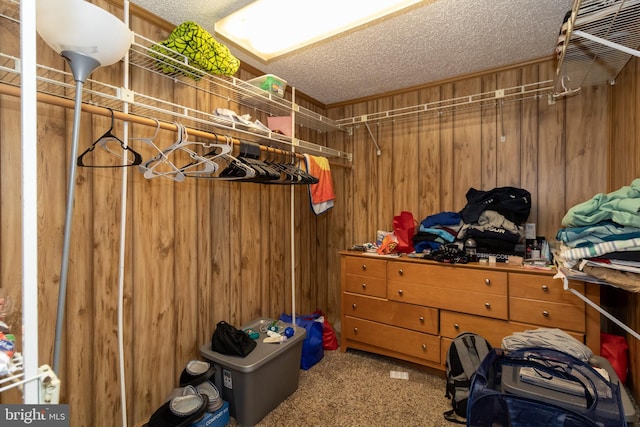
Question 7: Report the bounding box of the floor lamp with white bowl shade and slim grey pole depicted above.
[36,0,133,373]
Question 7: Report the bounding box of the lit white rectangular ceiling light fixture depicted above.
[215,0,420,61]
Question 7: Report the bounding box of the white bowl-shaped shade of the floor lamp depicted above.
[36,0,133,66]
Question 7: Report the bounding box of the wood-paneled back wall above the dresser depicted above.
[329,61,609,244]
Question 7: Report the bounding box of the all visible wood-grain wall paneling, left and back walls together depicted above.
[0,0,640,427]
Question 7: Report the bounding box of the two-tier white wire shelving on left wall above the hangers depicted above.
[0,3,352,162]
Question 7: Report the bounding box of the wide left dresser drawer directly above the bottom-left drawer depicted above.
[342,293,438,335]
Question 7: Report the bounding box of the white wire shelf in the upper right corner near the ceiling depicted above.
[554,0,640,97]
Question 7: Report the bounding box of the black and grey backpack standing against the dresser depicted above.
[444,332,492,424]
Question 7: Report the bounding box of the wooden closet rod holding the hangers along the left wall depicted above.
[0,83,304,159]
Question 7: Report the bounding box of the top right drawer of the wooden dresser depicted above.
[509,273,585,309]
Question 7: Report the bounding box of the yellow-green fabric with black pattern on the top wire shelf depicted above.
[151,21,240,80]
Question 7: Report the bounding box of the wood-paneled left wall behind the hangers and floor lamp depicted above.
[0,0,345,427]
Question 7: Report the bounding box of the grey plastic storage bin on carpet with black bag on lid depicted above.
[200,319,306,426]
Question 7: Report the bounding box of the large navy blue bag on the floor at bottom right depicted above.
[467,347,626,427]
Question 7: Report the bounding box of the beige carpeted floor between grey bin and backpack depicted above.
[230,350,455,427]
